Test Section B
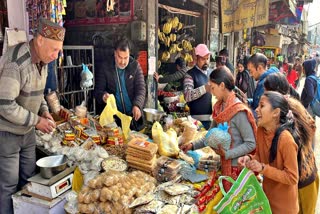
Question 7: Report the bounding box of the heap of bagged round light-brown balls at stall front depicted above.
[78,171,156,213]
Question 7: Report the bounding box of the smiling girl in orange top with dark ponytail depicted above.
[238,91,299,214]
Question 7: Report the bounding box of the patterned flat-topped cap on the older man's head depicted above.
[38,17,66,41]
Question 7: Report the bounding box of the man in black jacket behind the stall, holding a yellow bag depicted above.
[94,38,146,130]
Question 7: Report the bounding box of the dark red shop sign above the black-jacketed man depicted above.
[66,0,134,26]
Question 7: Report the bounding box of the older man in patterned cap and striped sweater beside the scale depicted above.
[0,18,65,214]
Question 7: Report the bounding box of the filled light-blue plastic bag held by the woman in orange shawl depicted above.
[205,122,231,150]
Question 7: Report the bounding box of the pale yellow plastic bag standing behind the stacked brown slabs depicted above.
[152,122,179,157]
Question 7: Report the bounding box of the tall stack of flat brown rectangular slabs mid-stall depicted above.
[126,138,158,172]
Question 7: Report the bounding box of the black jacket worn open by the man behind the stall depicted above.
[94,56,146,114]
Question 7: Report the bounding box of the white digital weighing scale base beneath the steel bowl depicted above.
[26,166,75,200]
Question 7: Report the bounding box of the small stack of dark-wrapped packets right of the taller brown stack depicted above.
[153,156,181,182]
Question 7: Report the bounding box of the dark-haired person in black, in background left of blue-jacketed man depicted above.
[236,59,255,98]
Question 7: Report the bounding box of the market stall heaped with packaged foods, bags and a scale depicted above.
[14,90,228,213]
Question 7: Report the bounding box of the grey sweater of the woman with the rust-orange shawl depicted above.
[192,112,256,166]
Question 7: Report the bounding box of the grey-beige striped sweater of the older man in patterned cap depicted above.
[0,43,48,135]
